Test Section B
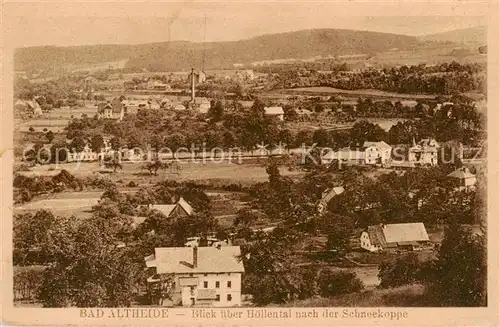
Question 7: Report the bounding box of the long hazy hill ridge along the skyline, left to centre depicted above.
[14,29,420,71]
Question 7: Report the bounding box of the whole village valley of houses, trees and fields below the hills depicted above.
[12,14,487,308]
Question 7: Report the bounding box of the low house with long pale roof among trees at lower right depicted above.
[360,223,430,252]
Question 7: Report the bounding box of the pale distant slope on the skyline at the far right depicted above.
[419,26,488,45]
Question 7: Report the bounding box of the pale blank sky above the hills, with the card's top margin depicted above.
[4,0,493,47]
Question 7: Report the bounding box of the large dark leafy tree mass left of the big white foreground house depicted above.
[39,218,145,307]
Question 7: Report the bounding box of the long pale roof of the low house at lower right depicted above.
[368,223,429,246]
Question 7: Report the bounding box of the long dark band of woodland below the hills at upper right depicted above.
[275,62,486,94]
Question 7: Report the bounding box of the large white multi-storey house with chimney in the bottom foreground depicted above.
[145,246,245,307]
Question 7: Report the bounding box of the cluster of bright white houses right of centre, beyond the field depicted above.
[321,139,439,168]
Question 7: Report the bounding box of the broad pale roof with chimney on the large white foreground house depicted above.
[145,246,245,274]
